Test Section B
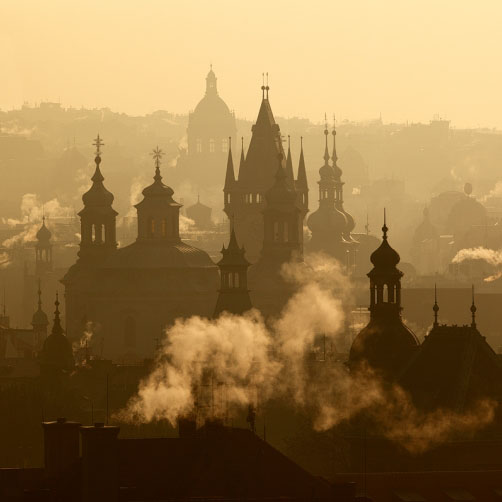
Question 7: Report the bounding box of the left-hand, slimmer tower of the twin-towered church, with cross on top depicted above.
[78,134,118,261]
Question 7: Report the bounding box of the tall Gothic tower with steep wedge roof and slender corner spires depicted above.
[224,81,308,262]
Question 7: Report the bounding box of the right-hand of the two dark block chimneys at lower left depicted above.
[80,422,120,502]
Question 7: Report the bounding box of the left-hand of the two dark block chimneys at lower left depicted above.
[42,418,80,480]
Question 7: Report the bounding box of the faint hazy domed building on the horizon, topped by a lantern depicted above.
[176,67,237,187]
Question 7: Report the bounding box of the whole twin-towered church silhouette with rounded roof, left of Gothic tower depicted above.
[62,137,218,361]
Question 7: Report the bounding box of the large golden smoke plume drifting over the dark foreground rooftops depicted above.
[116,256,495,452]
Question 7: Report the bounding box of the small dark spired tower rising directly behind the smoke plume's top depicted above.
[213,228,253,318]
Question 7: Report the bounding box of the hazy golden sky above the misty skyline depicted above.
[0,0,502,128]
